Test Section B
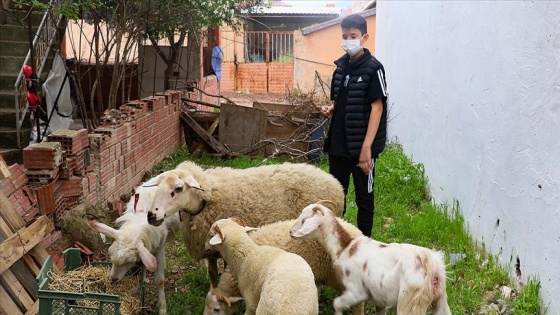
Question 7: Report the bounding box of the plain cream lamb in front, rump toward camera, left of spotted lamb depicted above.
[207,218,319,315]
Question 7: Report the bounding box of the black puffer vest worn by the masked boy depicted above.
[326,49,387,158]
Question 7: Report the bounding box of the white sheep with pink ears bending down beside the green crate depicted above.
[90,177,180,315]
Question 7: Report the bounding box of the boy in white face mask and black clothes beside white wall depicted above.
[321,14,387,236]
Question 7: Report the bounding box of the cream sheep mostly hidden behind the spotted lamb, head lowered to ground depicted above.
[204,219,364,315]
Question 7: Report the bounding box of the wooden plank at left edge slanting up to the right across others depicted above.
[0,216,54,273]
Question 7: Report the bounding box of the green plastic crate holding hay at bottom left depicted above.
[37,248,146,315]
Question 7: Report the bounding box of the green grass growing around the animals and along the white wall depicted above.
[140,145,545,315]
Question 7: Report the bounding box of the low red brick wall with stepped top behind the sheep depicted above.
[87,91,184,212]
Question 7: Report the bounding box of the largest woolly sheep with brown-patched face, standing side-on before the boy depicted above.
[143,162,344,286]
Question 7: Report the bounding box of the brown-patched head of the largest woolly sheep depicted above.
[143,168,204,226]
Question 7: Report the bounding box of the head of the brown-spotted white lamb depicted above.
[290,203,333,240]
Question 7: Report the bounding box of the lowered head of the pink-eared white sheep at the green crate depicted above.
[90,221,157,281]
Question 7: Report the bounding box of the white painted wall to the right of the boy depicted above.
[376,1,560,314]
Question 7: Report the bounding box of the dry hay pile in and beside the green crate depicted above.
[47,266,141,315]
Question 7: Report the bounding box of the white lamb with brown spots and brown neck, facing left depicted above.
[290,204,451,315]
